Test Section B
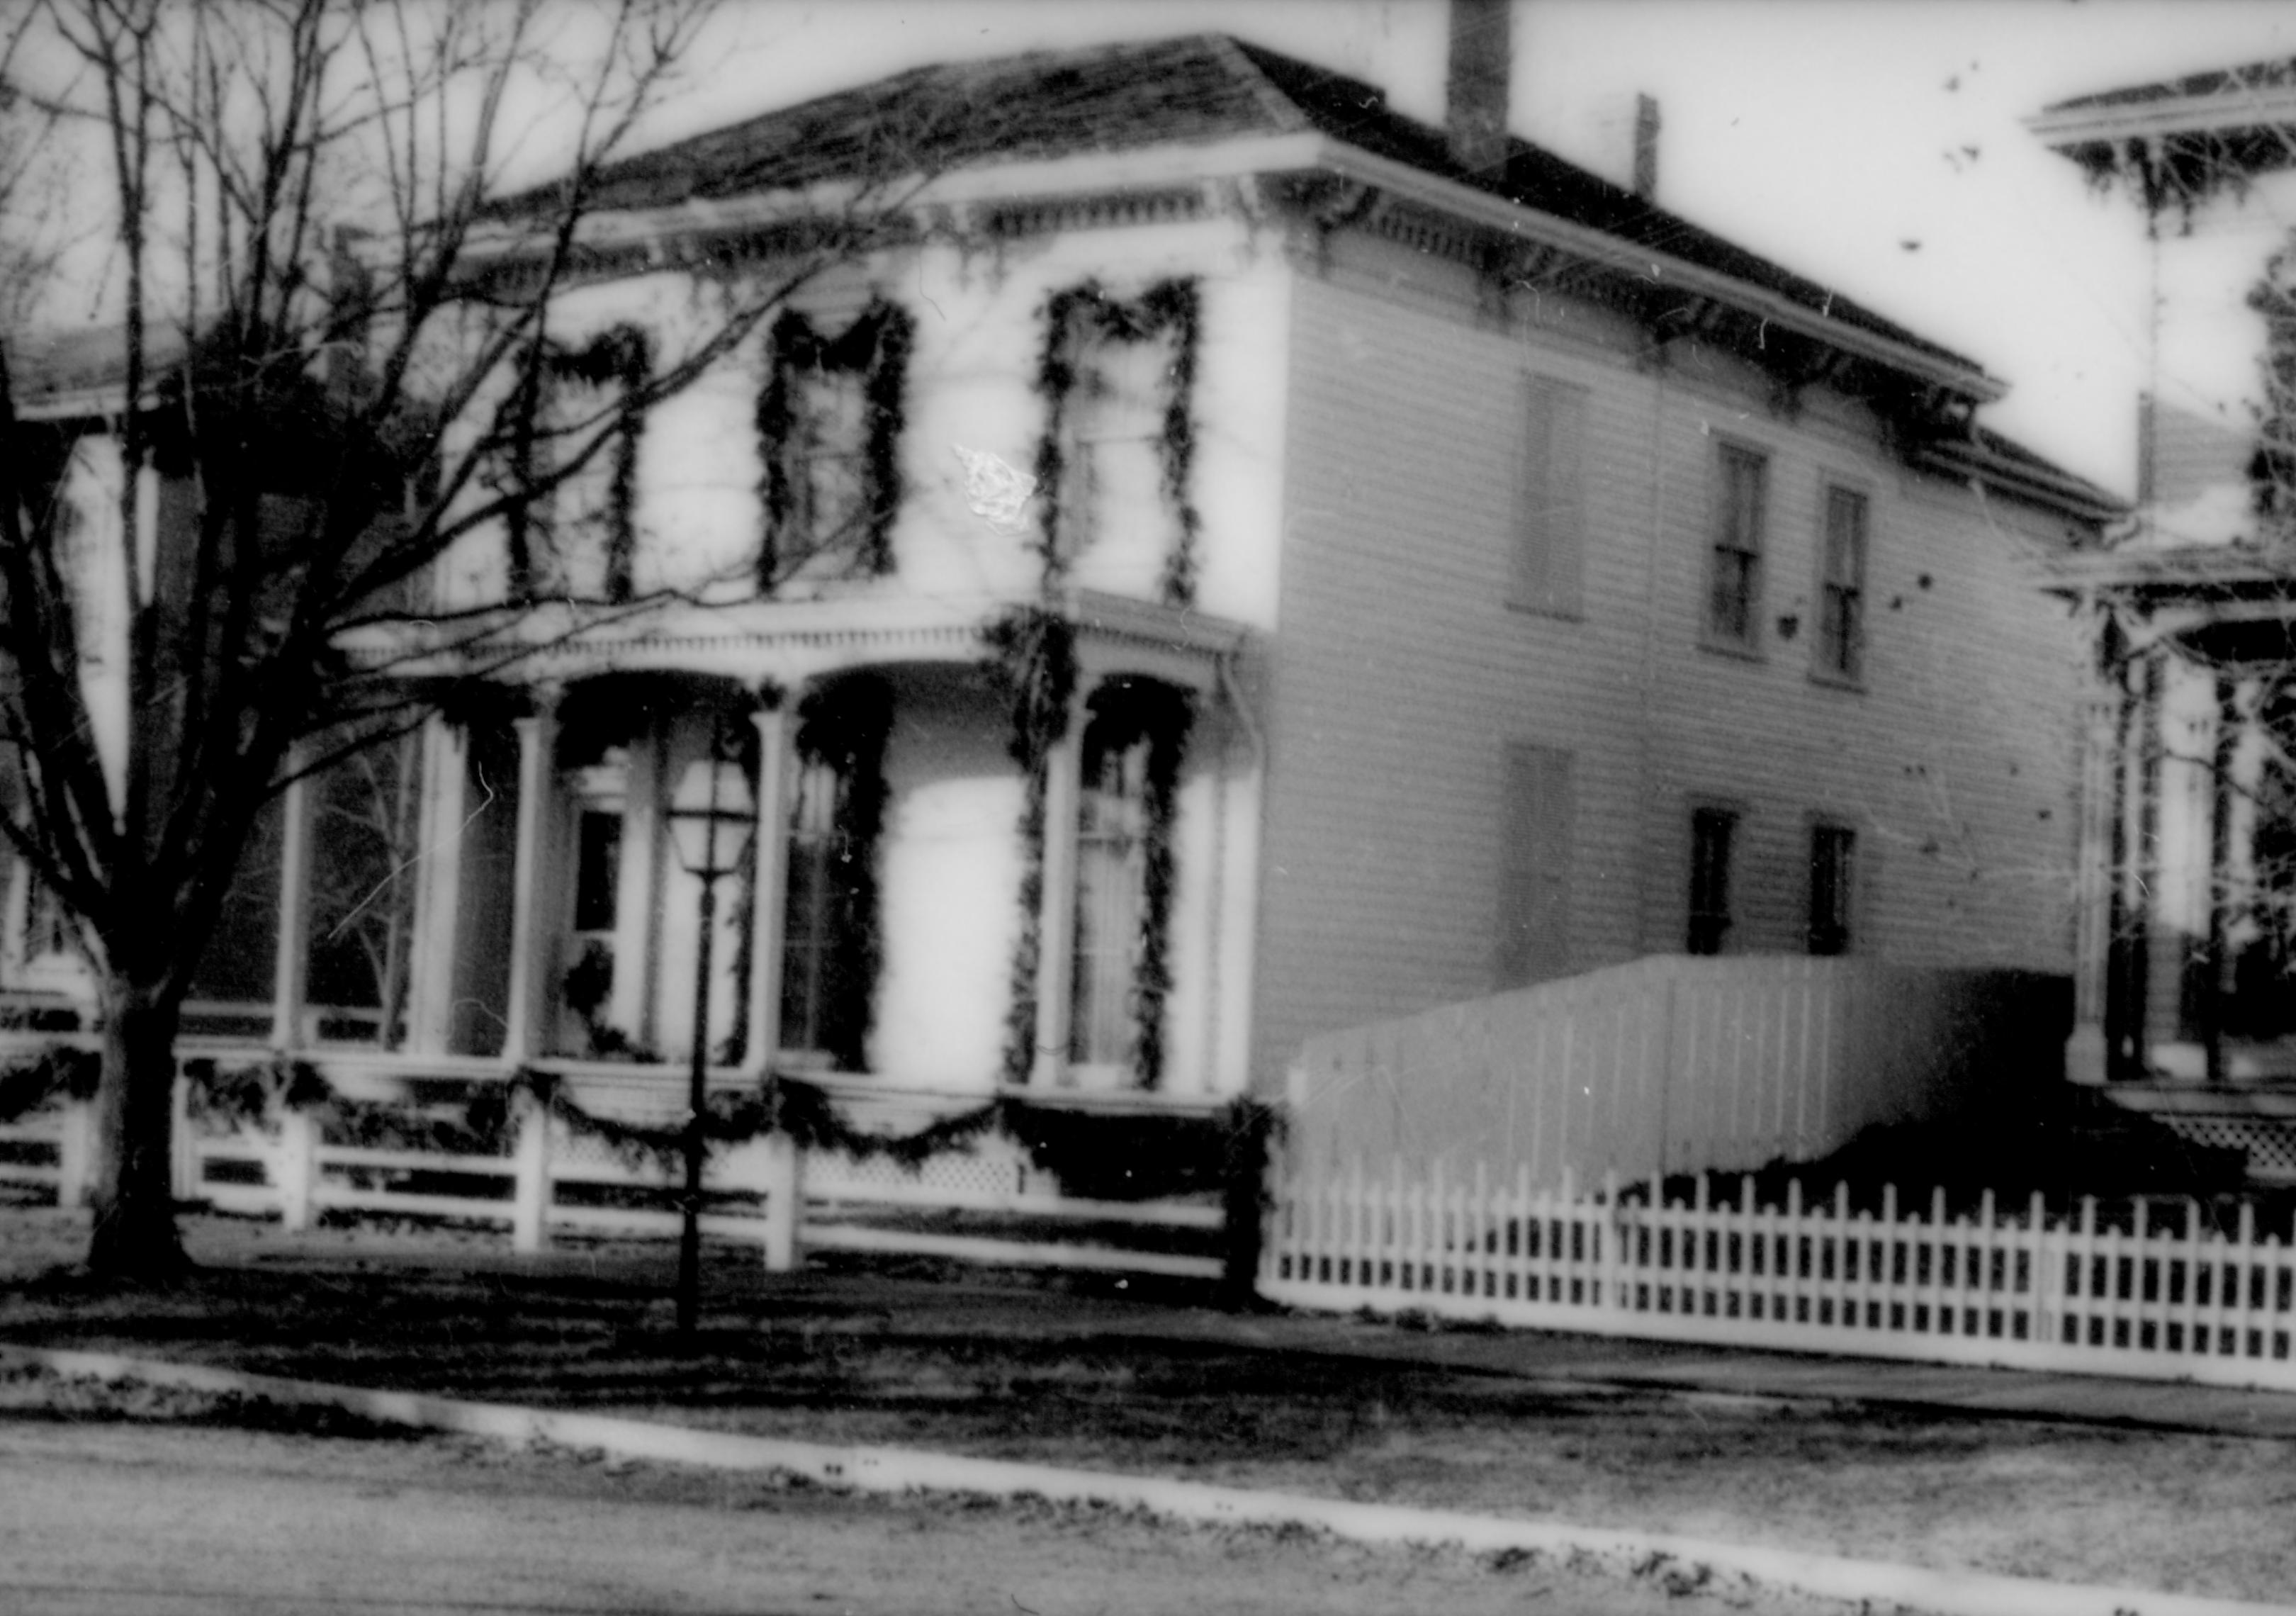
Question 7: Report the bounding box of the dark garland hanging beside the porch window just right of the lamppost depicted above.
[797,673,893,1072]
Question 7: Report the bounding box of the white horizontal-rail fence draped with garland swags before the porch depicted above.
[0,1084,1226,1279]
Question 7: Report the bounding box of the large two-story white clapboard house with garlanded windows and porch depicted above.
[9,37,2115,1099]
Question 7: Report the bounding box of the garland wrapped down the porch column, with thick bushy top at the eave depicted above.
[980,606,1077,1084]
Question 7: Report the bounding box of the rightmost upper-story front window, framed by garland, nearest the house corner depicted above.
[1037,280,1198,604]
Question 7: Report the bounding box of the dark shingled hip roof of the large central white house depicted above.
[592,35,1991,376]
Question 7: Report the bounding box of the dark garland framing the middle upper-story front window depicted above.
[758,296,916,590]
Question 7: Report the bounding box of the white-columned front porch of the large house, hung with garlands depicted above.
[0,593,1261,1104]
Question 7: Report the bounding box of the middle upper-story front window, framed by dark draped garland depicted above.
[758,298,914,590]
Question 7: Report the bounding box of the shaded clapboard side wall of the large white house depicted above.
[1259,214,2080,1072]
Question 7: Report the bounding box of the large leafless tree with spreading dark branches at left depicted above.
[0,0,913,1274]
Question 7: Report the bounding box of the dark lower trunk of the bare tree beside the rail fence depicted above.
[87,978,186,1279]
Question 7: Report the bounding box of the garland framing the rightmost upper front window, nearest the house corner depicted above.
[1035,280,1203,606]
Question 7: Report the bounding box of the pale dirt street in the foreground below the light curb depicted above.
[0,1407,1837,1616]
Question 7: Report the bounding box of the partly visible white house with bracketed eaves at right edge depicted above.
[2030,62,2296,1097]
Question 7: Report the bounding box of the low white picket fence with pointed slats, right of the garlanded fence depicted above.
[1261,1157,2296,1391]
